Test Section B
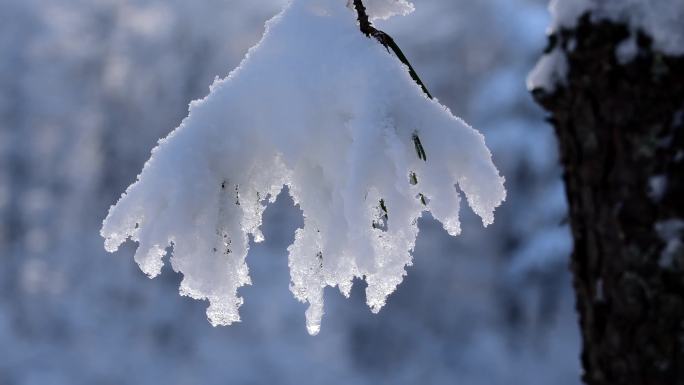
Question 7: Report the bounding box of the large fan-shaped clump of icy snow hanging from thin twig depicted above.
[101,0,505,334]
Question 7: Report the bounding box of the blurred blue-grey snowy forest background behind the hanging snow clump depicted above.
[0,0,579,385]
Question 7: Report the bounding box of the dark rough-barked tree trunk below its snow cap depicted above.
[533,15,684,385]
